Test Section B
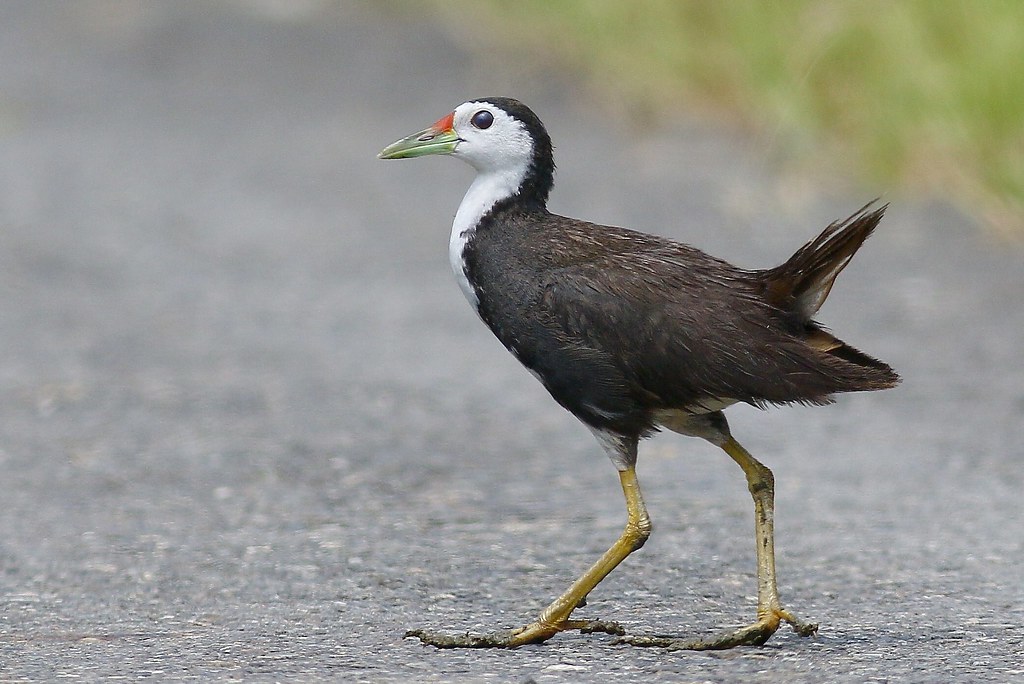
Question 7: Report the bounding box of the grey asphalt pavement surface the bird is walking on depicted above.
[0,2,1024,684]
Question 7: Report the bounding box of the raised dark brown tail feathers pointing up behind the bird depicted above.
[763,200,889,321]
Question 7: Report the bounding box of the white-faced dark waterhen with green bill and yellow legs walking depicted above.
[378,97,900,650]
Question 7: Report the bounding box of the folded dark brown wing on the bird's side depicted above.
[543,216,897,408]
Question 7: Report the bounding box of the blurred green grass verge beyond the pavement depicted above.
[435,0,1024,236]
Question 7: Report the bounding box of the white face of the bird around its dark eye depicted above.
[452,102,534,179]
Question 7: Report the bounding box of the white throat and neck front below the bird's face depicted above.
[449,166,526,309]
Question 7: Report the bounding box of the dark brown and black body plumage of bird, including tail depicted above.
[466,203,898,436]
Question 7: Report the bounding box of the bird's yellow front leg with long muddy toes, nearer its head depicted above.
[406,465,650,648]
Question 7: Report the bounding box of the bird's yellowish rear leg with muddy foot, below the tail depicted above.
[620,435,818,650]
